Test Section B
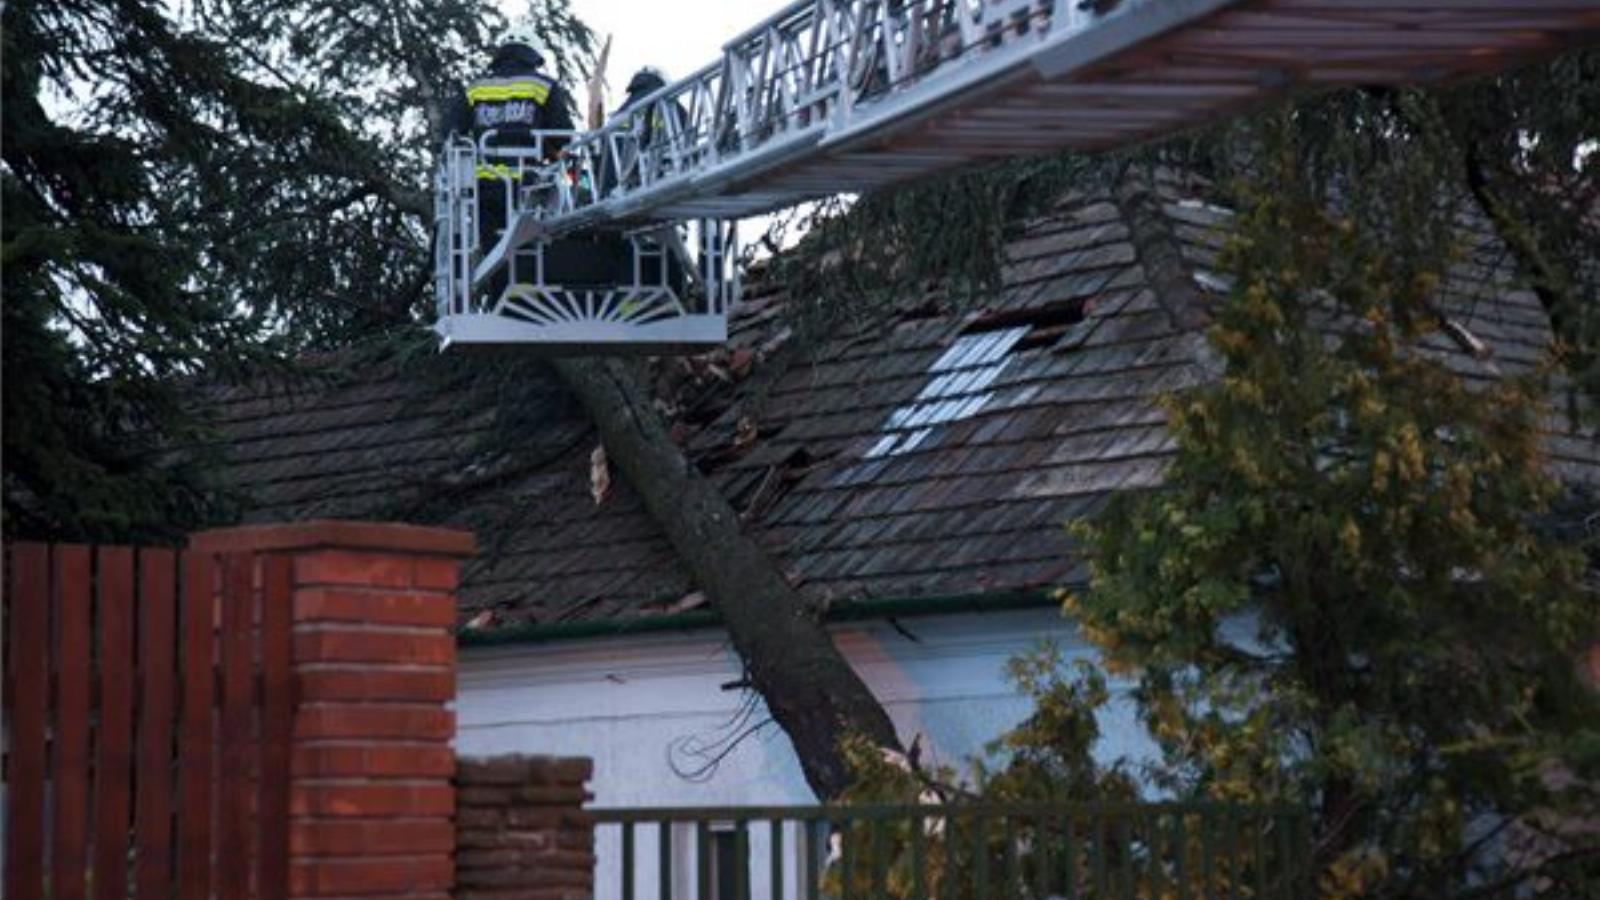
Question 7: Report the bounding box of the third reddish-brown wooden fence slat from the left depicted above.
[94,546,133,900]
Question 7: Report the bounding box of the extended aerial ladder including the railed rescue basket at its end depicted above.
[435,0,1600,354]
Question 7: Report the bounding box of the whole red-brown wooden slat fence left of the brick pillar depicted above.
[3,543,293,900]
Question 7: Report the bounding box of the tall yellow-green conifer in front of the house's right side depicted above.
[1066,136,1600,897]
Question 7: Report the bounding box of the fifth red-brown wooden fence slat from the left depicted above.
[178,552,216,900]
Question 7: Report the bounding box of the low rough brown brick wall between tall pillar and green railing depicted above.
[456,756,595,900]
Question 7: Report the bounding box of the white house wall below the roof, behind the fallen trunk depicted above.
[456,609,1149,897]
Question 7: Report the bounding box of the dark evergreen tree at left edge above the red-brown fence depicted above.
[0,2,286,538]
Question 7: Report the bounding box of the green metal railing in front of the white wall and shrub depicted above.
[594,804,1314,900]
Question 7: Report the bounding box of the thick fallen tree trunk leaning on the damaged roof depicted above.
[554,359,899,799]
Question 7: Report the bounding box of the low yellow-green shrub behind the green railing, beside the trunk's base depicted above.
[822,645,1310,900]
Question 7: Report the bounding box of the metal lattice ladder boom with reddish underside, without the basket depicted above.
[533,0,1600,234]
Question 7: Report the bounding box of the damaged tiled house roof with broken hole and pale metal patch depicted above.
[200,176,1600,631]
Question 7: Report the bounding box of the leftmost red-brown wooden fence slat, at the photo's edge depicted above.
[5,544,50,900]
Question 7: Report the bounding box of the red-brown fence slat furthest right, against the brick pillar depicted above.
[258,554,294,897]
